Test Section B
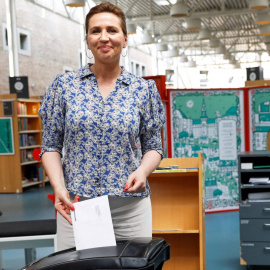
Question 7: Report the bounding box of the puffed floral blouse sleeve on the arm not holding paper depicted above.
[140,80,166,158]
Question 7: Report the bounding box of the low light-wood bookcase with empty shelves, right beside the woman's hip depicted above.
[148,153,206,270]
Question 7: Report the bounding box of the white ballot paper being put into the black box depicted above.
[70,196,116,250]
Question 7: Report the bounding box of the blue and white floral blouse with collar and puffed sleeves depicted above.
[39,65,165,198]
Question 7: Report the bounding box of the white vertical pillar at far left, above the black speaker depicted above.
[6,0,19,77]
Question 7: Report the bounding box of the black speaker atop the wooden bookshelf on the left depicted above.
[9,76,29,98]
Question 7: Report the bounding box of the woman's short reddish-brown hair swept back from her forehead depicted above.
[85,2,127,36]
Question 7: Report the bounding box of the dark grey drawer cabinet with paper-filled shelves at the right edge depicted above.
[238,151,270,267]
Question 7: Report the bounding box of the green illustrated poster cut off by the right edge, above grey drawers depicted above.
[249,88,270,151]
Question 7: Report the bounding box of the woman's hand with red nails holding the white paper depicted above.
[54,188,79,225]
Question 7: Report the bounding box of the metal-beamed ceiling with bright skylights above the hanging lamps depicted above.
[24,0,270,64]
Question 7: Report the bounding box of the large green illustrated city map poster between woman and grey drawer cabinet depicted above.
[170,90,245,212]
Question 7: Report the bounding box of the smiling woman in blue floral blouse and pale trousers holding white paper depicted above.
[39,2,165,250]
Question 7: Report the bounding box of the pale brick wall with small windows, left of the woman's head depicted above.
[0,0,81,96]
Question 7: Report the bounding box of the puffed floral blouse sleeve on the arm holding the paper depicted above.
[39,75,65,157]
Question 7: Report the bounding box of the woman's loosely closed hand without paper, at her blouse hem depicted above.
[123,168,146,193]
